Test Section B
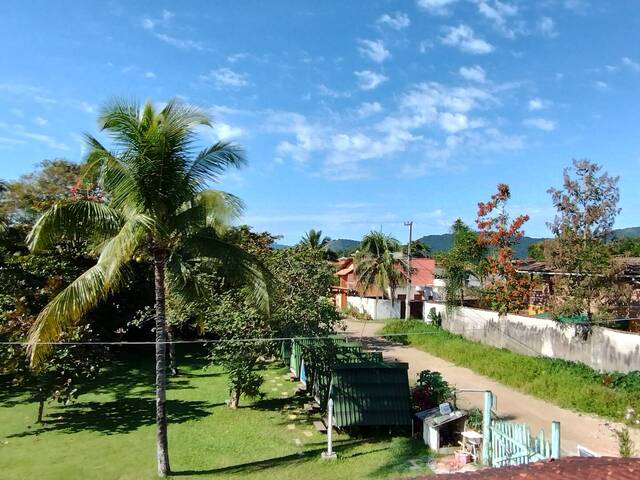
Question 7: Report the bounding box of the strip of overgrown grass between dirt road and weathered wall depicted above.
[381,320,640,421]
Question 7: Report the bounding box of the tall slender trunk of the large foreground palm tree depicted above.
[154,251,171,477]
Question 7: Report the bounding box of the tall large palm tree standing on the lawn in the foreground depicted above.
[27,100,268,476]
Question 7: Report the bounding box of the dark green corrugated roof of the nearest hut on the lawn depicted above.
[331,363,411,428]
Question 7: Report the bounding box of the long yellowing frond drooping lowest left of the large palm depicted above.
[28,215,150,368]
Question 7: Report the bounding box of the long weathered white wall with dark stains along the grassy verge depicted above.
[425,302,640,372]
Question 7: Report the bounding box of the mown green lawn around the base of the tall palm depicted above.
[0,351,429,480]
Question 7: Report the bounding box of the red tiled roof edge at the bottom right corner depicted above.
[415,457,640,480]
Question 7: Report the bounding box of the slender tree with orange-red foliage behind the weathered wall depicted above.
[476,183,531,315]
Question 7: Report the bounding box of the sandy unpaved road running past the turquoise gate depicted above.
[346,320,640,456]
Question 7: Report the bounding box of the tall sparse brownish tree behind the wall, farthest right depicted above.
[545,160,620,321]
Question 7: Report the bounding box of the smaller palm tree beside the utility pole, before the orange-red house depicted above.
[354,231,409,317]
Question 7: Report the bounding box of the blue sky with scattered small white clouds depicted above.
[0,0,640,243]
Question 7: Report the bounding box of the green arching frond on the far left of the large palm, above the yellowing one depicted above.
[27,200,123,252]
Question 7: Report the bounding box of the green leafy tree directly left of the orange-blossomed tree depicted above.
[437,219,487,308]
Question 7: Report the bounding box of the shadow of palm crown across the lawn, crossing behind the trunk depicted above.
[6,397,222,437]
